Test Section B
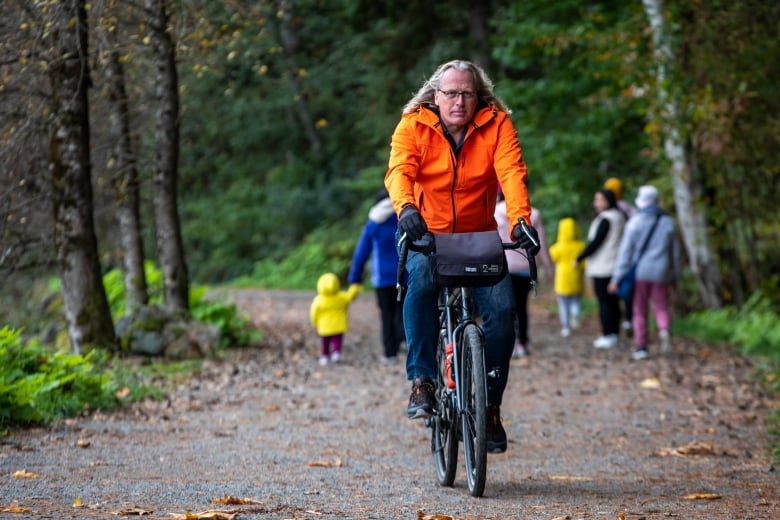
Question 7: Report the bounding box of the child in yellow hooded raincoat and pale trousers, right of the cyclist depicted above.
[550,218,585,338]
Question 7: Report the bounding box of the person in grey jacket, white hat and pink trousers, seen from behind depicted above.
[608,185,680,359]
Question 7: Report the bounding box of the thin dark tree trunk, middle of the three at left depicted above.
[105,31,149,314]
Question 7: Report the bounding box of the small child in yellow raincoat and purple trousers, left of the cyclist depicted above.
[309,273,361,365]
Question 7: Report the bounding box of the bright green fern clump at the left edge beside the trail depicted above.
[0,327,118,431]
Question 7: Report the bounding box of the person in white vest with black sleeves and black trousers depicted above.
[575,188,626,348]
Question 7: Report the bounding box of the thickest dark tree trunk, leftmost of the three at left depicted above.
[49,0,119,352]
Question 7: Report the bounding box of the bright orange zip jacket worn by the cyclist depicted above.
[385,105,531,233]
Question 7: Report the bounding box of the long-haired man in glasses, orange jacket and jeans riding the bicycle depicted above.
[385,60,539,453]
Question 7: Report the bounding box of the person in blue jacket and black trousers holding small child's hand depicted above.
[347,189,406,363]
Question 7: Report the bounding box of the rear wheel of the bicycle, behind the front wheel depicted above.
[431,337,460,487]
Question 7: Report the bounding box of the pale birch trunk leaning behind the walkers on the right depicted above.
[642,0,722,308]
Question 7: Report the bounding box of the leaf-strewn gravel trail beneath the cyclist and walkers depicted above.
[0,290,780,520]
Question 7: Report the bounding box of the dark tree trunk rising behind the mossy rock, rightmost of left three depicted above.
[146,0,189,311]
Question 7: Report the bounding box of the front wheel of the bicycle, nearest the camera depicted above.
[459,324,487,497]
